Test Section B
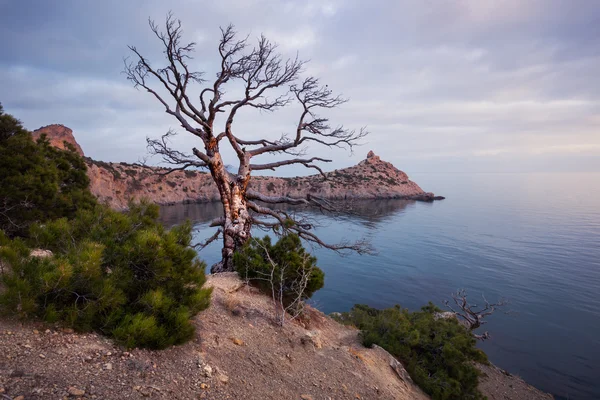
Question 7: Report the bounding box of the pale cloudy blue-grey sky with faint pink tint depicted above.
[0,0,600,175]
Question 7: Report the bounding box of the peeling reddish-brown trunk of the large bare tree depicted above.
[210,153,252,273]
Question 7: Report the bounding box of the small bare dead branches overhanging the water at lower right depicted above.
[444,289,508,340]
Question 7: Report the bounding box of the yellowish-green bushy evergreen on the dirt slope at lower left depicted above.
[0,204,211,349]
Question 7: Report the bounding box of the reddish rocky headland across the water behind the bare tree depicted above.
[34,125,443,208]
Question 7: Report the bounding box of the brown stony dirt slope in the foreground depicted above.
[0,273,551,400]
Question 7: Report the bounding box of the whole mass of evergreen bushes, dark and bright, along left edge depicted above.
[0,104,210,348]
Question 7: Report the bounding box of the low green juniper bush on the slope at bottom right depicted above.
[337,303,487,399]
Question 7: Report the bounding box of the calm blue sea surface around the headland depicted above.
[162,174,600,399]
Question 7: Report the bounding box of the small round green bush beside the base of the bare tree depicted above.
[233,234,325,306]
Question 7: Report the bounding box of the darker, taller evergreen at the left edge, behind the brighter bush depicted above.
[0,107,96,236]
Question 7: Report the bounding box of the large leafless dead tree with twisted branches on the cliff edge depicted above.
[125,14,368,272]
